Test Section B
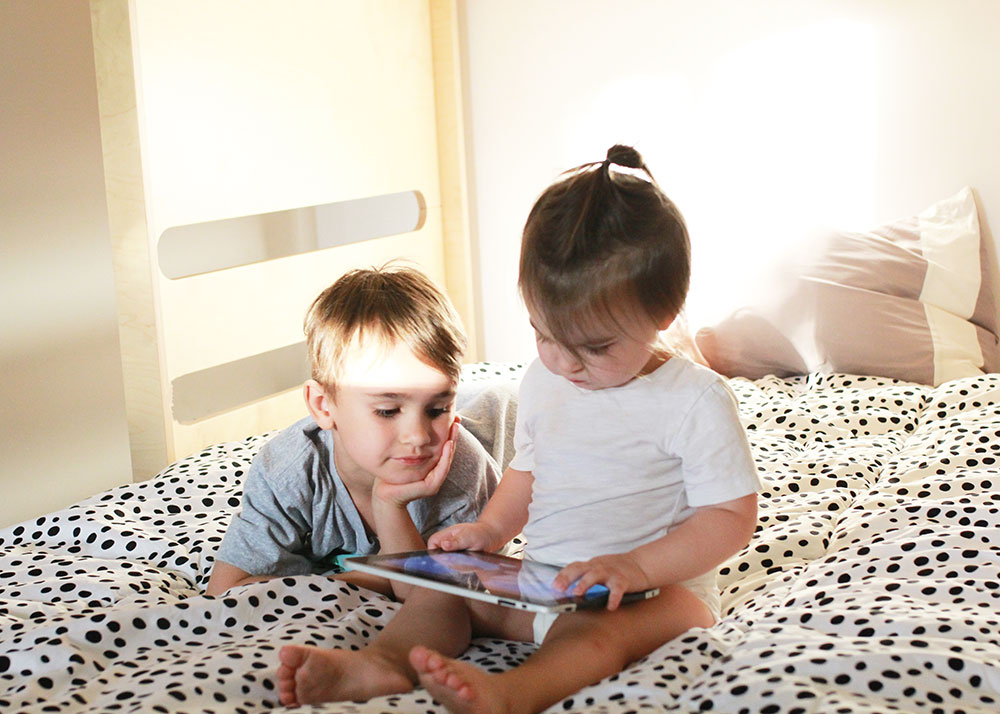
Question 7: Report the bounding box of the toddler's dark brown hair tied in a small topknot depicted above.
[518,144,691,345]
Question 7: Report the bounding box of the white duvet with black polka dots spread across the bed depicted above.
[0,365,1000,714]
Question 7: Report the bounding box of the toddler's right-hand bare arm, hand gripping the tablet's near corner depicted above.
[554,493,757,610]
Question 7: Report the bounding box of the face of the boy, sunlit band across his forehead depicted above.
[330,343,455,484]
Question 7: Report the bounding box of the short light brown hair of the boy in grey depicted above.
[305,264,466,396]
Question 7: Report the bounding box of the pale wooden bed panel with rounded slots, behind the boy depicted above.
[92,0,476,479]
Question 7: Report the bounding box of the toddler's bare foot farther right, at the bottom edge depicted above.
[410,646,511,714]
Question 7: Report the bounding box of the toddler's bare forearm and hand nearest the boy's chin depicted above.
[427,468,535,551]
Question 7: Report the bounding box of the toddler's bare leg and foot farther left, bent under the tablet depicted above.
[277,588,471,706]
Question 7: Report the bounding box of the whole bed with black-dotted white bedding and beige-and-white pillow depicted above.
[9,145,1000,714]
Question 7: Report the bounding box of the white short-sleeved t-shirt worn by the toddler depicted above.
[510,357,760,578]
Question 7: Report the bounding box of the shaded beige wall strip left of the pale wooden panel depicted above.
[0,0,131,526]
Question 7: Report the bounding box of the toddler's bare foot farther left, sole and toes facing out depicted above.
[278,645,413,707]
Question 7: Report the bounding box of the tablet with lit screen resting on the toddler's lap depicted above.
[342,550,660,612]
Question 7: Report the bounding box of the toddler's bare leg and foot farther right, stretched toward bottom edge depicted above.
[410,586,713,714]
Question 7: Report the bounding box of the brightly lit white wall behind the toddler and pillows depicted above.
[463,0,1000,360]
